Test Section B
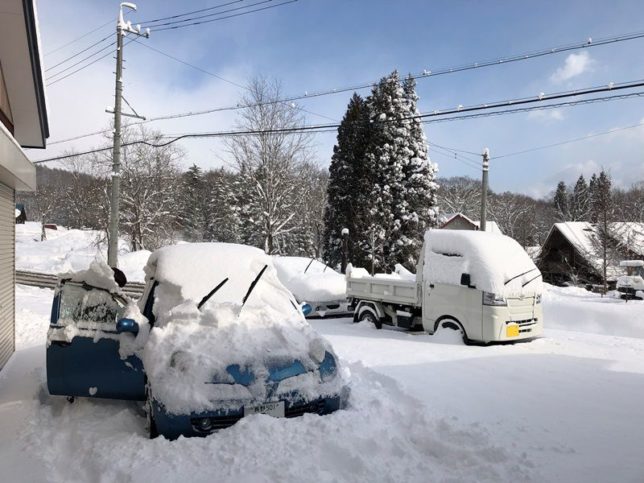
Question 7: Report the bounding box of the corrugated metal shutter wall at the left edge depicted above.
[0,183,16,368]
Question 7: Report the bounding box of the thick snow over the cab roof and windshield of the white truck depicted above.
[423,230,542,297]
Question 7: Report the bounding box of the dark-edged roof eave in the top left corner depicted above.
[0,0,49,148]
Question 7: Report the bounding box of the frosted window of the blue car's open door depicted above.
[59,282,125,323]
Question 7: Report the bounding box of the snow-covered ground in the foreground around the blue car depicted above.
[0,286,644,482]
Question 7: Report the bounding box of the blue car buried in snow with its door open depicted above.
[47,248,349,439]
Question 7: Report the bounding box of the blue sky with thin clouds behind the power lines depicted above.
[30,0,644,195]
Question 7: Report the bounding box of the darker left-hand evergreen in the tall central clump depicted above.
[324,93,372,266]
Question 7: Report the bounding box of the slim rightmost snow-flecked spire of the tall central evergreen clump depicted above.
[394,76,438,271]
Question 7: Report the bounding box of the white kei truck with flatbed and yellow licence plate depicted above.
[347,229,543,344]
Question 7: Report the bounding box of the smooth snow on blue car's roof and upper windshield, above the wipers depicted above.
[144,243,290,304]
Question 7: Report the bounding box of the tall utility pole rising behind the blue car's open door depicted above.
[107,2,150,268]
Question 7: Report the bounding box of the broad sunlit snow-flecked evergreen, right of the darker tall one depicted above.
[365,71,438,269]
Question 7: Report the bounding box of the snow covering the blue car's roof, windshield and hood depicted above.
[143,243,341,414]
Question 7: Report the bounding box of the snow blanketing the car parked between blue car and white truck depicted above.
[273,256,347,302]
